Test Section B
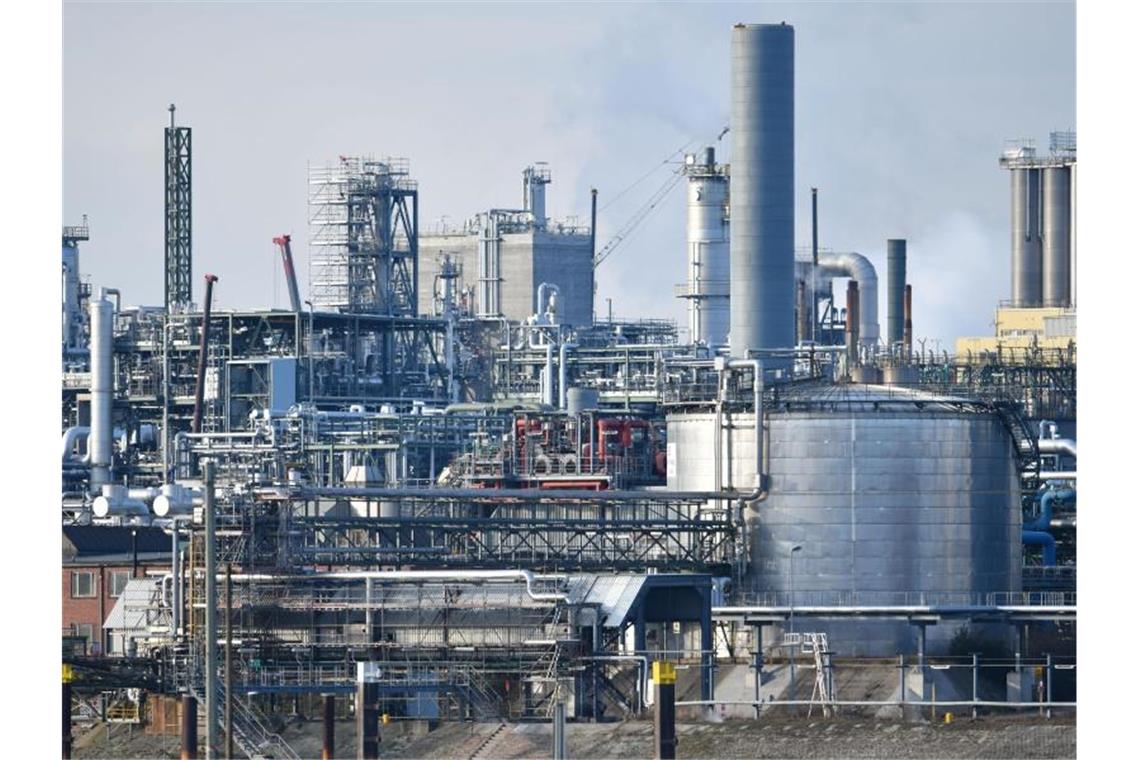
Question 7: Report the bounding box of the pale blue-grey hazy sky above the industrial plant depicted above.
[64,2,1076,348]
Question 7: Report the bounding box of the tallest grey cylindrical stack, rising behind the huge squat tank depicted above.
[730,24,796,365]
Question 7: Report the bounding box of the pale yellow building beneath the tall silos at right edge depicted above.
[954,307,1076,362]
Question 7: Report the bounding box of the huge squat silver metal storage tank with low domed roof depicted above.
[668,385,1021,656]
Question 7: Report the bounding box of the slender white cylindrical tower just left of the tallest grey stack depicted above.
[686,148,728,345]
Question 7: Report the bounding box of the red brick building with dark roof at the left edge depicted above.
[62,525,171,654]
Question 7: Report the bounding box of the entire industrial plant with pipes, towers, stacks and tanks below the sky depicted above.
[60,17,1077,758]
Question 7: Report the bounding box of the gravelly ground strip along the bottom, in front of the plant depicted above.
[74,716,1076,760]
